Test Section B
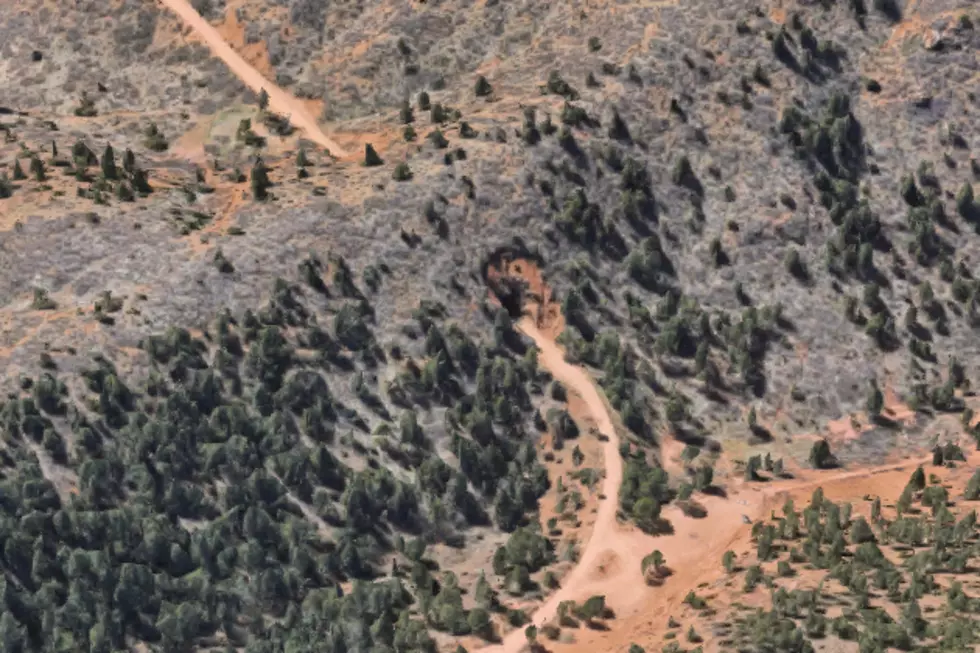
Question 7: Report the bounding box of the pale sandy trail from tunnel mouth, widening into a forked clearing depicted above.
[479,316,930,653]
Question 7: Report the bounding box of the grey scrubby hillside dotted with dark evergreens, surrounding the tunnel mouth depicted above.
[0,0,980,653]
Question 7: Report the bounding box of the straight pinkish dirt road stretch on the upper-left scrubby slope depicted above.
[160,0,347,157]
